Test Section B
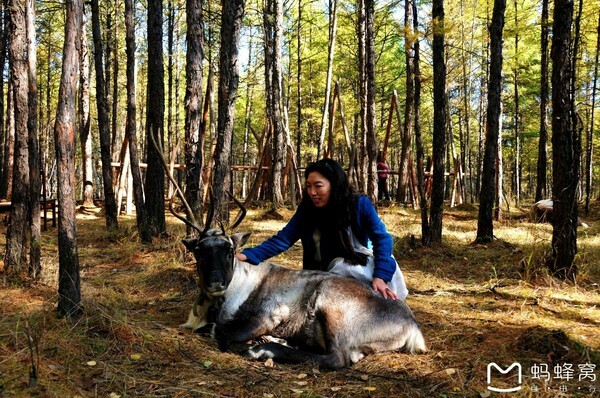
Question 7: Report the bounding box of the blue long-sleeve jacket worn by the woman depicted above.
[242,195,396,282]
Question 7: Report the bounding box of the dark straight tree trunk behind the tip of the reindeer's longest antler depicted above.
[144,0,167,236]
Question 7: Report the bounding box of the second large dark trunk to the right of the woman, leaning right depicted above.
[476,0,506,243]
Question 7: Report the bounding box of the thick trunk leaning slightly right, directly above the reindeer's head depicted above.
[213,0,244,225]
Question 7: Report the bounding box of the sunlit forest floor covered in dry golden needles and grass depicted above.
[0,203,600,398]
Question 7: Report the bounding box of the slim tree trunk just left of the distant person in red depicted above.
[365,0,377,203]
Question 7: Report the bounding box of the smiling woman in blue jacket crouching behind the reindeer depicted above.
[237,159,407,300]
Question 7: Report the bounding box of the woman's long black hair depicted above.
[302,158,358,230]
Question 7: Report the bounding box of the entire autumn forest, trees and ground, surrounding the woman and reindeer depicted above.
[0,0,600,397]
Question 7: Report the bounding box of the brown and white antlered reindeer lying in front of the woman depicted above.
[151,133,426,369]
